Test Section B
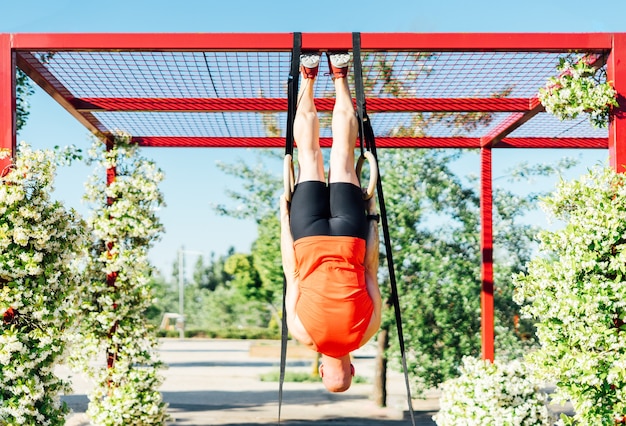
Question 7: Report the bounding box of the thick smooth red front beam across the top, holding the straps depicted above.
[6,33,613,52]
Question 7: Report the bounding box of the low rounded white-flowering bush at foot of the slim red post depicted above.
[433,357,553,426]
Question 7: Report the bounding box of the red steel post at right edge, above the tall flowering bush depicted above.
[607,33,626,172]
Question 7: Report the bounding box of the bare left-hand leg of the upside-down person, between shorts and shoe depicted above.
[293,69,326,182]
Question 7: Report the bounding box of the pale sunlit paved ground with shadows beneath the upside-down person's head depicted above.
[60,339,437,426]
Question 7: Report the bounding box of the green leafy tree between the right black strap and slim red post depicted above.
[380,150,480,390]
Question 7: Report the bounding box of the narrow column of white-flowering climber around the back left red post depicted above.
[73,136,167,426]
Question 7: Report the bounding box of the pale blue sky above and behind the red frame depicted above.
[0,0,626,275]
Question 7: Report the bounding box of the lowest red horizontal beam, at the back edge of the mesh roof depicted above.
[132,136,608,149]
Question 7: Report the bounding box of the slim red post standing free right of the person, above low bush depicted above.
[480,147,495,361]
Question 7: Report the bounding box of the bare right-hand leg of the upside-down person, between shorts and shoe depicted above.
[329,76,359,186]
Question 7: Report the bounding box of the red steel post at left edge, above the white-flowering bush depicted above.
[0,34,16,176]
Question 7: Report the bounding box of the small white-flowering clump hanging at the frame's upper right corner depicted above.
[539,57,618,128]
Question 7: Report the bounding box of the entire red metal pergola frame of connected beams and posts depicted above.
[0,33,626,360]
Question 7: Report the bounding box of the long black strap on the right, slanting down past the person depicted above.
[352,32,415,426]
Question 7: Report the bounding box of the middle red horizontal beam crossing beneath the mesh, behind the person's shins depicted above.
[71,98,533,112]
